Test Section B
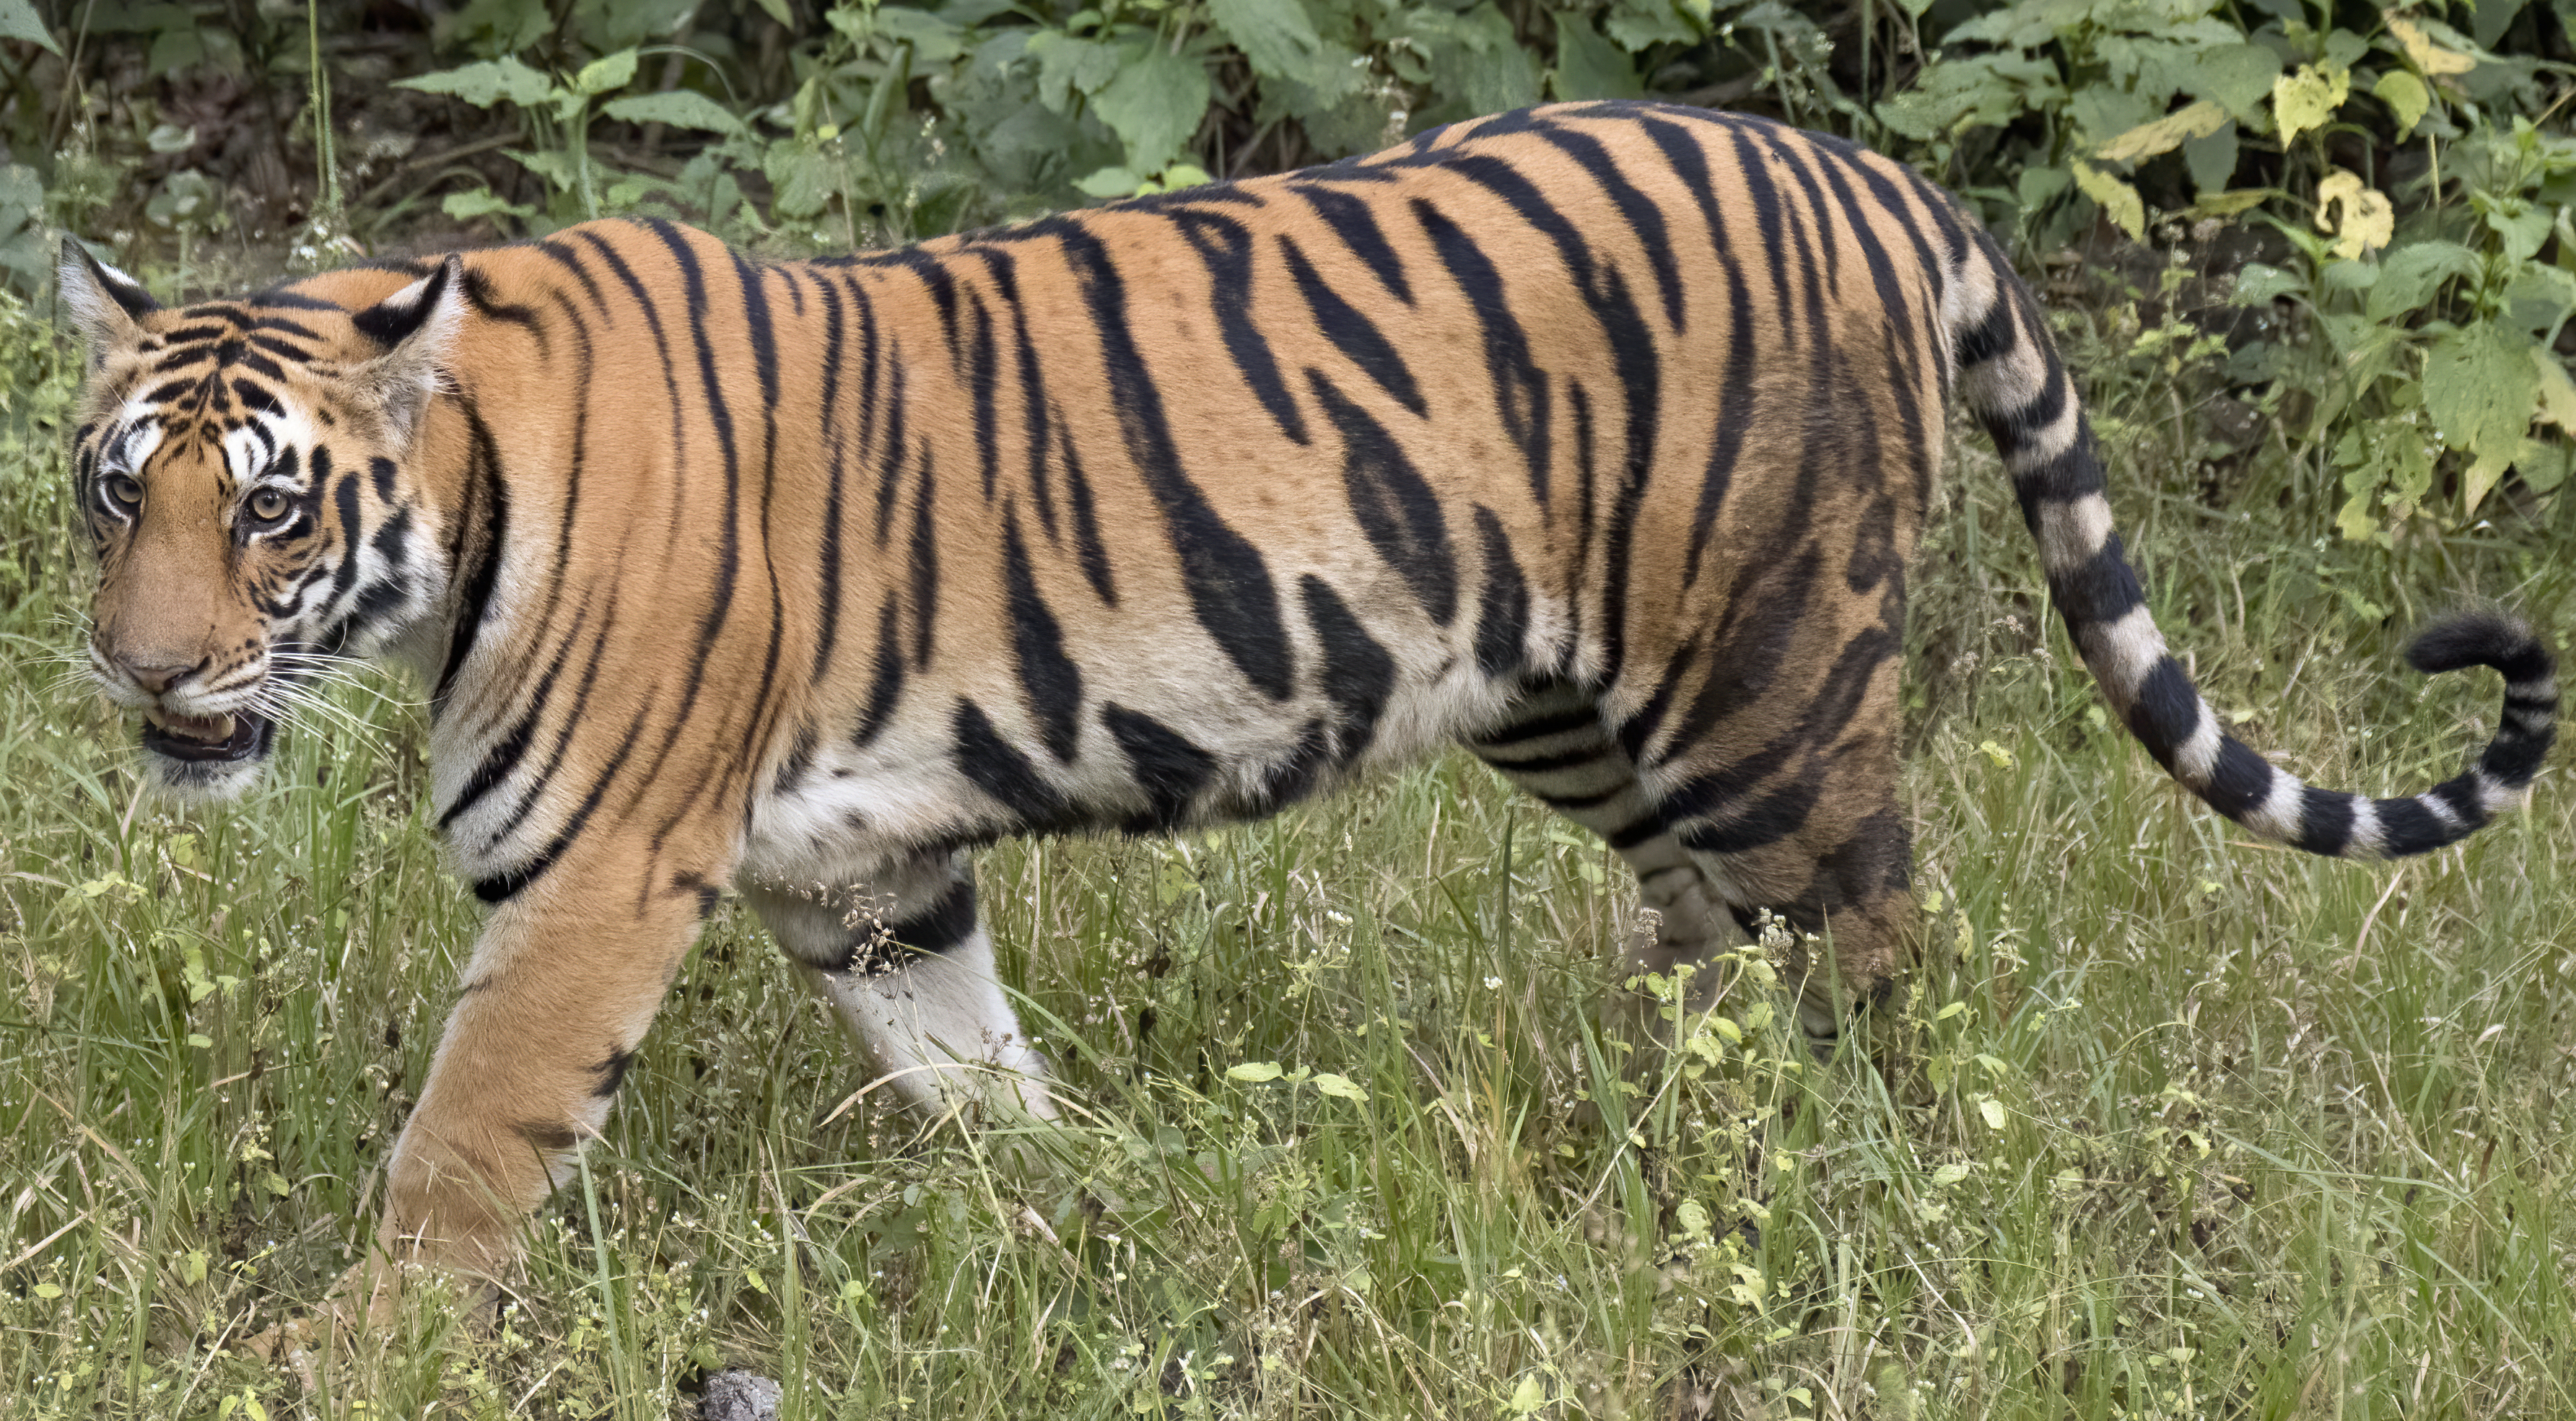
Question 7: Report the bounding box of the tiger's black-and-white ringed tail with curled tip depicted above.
[1945,235,2558,857]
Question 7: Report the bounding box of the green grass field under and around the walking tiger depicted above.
[0,278,2576,1421]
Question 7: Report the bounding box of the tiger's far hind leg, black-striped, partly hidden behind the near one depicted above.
[1466,682,1744,1009]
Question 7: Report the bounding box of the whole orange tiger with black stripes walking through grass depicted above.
[59,103,2558,1318]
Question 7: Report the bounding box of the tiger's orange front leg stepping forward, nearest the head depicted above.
[358,834,724,1313]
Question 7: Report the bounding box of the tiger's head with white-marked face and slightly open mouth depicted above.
[62,242,466,798]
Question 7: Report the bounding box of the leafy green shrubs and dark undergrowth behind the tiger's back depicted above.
[0,0,2576,543]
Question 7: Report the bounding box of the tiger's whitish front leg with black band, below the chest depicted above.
[744,852,1056,1120]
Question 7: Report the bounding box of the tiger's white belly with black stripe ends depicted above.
[737,597,1566,886]
